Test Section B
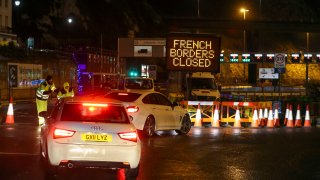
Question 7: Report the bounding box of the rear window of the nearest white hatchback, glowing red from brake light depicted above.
[61,103,130,123]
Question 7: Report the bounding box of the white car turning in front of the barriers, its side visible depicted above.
[105,90,191,136]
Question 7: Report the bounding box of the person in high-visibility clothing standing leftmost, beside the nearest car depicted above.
[36,75,56,125]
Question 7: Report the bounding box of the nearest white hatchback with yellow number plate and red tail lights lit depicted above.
[40,97,141,178]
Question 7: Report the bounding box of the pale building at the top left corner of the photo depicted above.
[0,0,17,45]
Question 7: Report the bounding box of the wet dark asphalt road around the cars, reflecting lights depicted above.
[0,104,320,180]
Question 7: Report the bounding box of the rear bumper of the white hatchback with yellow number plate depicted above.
[48,142,141,168]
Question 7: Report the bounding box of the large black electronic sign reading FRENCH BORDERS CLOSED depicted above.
[166,33,221,73]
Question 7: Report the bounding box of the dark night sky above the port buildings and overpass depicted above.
[13,0,320,49]
